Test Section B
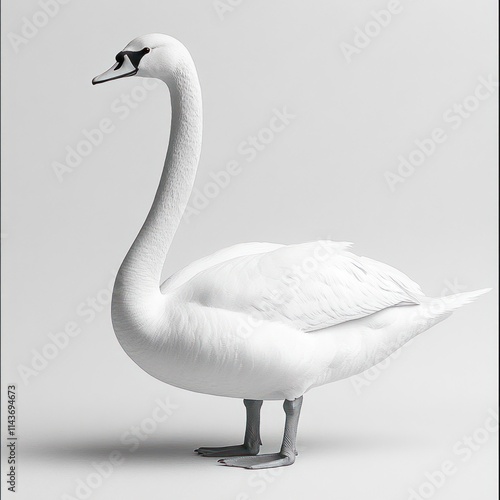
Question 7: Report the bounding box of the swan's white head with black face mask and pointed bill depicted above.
[92,33,188,85]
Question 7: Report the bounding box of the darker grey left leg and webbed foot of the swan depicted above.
[194,399,262,457]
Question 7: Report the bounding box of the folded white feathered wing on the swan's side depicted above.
[170,241,423,331]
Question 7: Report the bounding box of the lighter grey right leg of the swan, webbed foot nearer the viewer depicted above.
[219,396,303,469]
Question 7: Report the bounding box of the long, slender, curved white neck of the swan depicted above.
[113,57,202,305]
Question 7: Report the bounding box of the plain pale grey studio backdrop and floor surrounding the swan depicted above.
[2,0,498,500]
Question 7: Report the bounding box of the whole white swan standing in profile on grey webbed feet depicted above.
[92,34,487,469]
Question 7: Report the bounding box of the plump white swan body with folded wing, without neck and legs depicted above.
[119,241,480,400]
